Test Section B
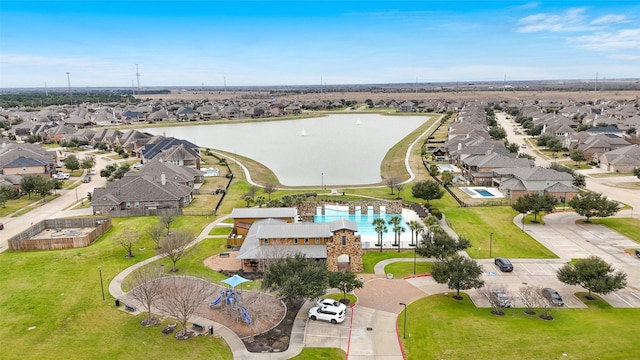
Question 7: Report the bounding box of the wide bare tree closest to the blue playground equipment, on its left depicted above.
[157,276,215,339]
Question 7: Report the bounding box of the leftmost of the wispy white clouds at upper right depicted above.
[518,8,587,32]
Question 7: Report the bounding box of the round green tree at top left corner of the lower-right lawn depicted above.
[431,255,484,300]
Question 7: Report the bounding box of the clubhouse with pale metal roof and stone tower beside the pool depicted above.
[227,208,363,271]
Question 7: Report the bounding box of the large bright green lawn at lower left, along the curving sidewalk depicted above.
[0,217,232,359]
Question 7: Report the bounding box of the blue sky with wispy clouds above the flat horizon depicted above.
[0,0,640,88]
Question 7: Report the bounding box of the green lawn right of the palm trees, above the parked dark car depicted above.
[446,206,556,259]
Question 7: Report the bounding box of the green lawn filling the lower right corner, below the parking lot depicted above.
[398,294,640,360]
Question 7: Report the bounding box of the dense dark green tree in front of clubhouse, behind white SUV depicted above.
[262,253,328,303]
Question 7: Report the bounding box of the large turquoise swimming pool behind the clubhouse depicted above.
[313,205,411,248]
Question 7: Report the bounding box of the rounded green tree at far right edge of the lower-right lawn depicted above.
[557,256,627,299]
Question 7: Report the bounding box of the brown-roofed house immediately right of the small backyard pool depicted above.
[493,166,578,202]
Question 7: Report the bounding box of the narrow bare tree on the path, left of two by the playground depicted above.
[127,266,162,326]
